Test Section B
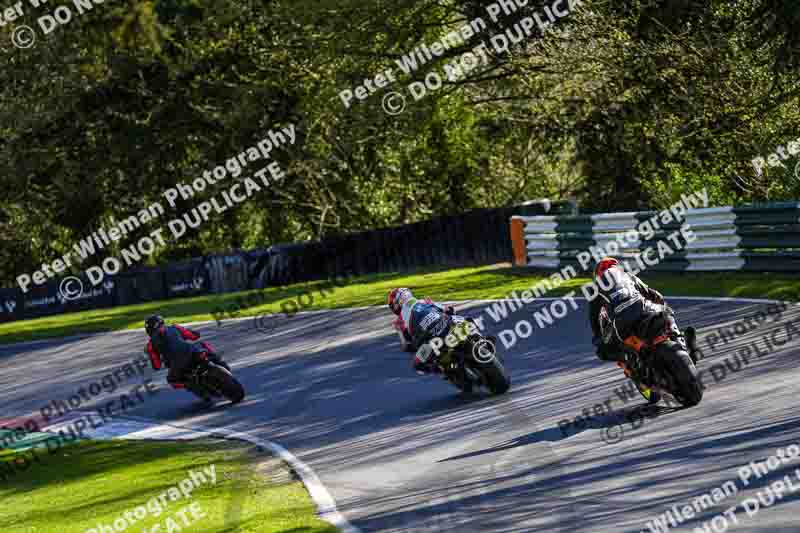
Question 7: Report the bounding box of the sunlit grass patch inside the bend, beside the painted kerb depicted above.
[0,440,337,533]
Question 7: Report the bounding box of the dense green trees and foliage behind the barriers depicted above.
[0,0,800,283]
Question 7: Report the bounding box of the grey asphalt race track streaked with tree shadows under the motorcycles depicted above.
[0,299,800,533]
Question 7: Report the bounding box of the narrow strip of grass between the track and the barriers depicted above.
[0,265,800,344]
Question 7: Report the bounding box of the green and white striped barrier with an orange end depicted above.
[511,202,800,272]
